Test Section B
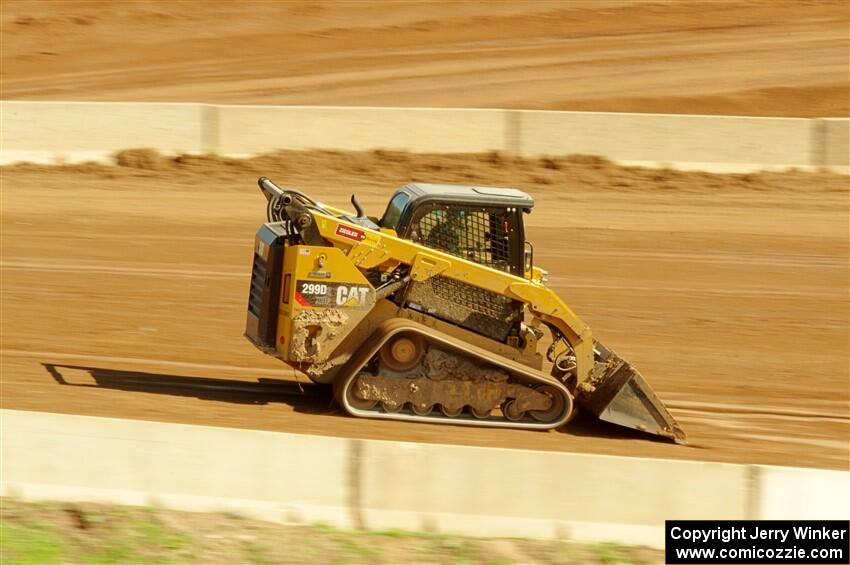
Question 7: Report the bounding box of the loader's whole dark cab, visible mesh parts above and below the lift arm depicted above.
[378,183,534,343]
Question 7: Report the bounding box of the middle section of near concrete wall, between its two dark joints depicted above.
[360,436,750,547]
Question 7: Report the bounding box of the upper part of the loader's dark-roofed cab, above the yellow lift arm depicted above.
[378,183,534,276]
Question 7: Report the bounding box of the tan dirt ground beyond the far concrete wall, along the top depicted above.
[0,0,850,117]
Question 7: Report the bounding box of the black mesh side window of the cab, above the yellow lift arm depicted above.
[411,208,511,272]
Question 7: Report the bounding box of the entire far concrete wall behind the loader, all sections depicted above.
[0,101,850,173]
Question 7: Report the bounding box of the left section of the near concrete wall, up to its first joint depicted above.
[0,410,350,527]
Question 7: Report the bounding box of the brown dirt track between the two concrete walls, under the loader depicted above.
[0,152,850,469]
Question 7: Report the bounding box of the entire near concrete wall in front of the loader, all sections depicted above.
[0,410,850,547]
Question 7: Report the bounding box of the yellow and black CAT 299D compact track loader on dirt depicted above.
[245,177,685,443]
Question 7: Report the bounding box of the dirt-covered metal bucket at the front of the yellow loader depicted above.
[576,343,686,443]
